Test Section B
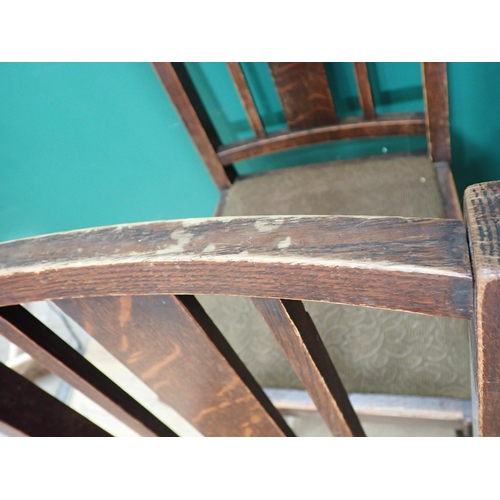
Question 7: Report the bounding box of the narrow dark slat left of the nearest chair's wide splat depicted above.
[0,306,175,436]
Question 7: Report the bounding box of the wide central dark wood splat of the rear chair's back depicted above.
[268,62,337,130]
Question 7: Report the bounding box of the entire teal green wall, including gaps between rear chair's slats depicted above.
[0,63,500,241]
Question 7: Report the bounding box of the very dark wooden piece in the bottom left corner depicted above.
[0,363,109,437]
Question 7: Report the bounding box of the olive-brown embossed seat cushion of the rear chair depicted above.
[198,157,470,398]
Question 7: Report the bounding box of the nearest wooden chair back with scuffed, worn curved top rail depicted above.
[0,182,500,436]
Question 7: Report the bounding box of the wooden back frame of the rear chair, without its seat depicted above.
[153,62,462,219]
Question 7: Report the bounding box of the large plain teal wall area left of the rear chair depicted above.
[0,64,217,240]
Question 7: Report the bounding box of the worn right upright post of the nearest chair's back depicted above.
[464,182,500,436]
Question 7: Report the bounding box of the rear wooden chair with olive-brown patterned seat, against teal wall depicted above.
[147,63,471,434]
